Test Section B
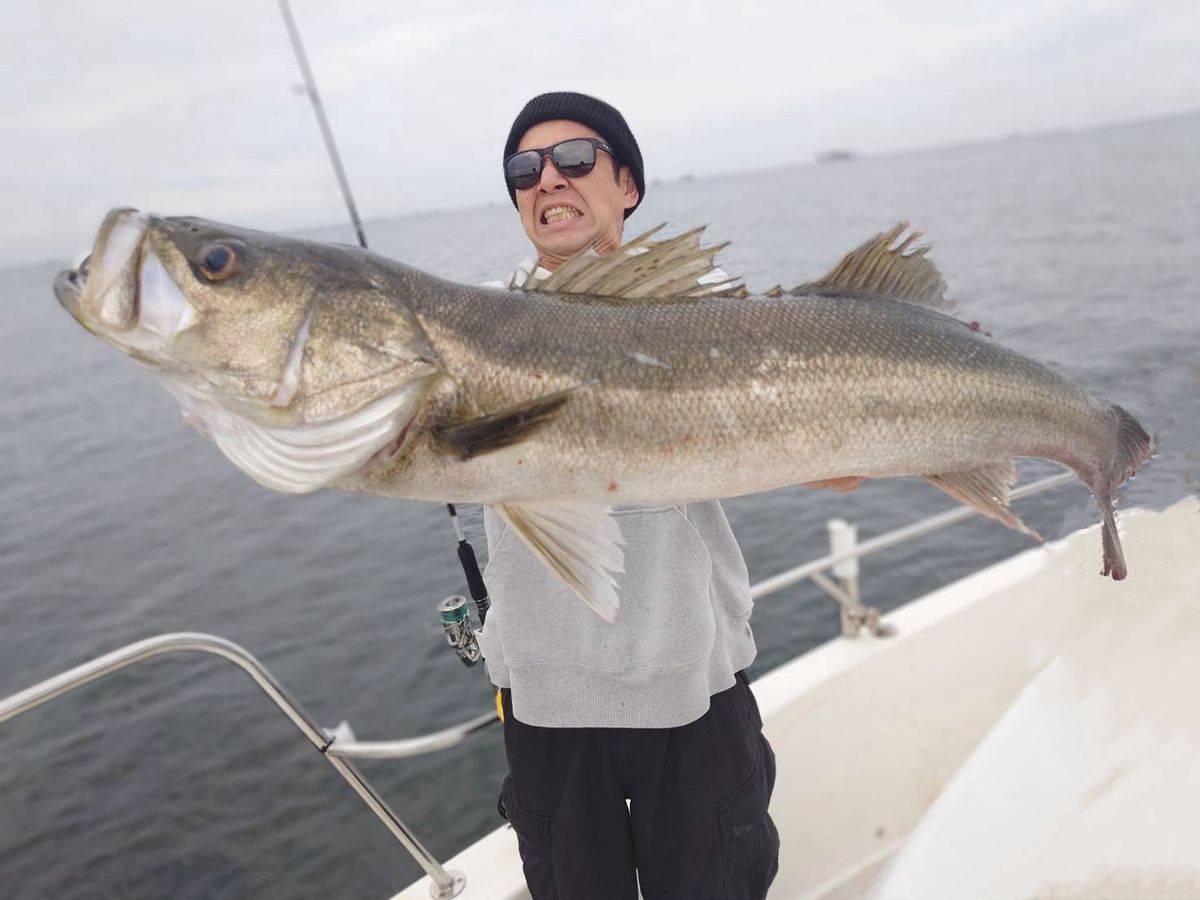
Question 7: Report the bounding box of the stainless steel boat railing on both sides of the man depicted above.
[0,472,1074,898]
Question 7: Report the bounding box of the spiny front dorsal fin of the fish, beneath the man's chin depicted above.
[520,224,746,300]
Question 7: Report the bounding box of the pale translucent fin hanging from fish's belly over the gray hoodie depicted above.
[493,500,625,622]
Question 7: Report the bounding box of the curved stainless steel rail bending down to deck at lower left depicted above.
[0,631,478,900]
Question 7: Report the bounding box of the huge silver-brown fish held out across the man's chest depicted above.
[55,210,1151,619]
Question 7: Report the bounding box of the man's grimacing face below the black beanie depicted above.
[516,119,637,266]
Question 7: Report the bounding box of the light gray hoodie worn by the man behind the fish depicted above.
[481,260,756,728]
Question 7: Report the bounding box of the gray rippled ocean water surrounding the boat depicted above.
[0,115,1200,900]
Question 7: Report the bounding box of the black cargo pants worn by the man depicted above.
[500,672,779,900]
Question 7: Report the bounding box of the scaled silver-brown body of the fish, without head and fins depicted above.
[372,274,1111,503]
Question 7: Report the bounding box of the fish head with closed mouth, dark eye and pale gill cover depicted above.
[54,209,439,492]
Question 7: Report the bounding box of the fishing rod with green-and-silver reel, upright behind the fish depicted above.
[280,0,492,666]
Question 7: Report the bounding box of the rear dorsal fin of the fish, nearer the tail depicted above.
[791,222,955,312]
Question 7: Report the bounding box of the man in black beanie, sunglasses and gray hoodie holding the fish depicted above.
[485,92,857,900]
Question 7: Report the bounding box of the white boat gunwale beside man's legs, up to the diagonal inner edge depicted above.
[394,498,1200,900]
